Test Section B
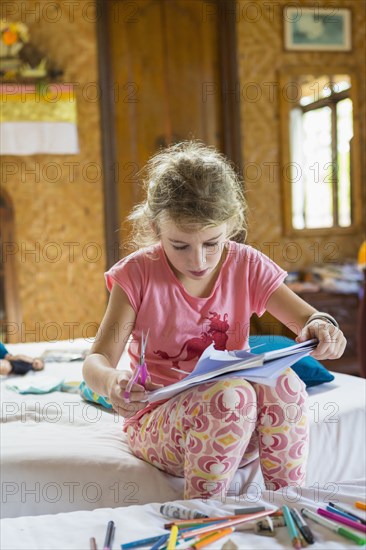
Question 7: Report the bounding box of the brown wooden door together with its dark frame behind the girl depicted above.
[99,0,239,264]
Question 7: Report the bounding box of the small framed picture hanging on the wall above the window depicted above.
[283,5,352,52]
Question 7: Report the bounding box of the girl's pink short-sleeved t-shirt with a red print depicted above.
[105,241,287,428]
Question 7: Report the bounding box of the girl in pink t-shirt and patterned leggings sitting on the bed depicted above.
[83,141,346,499]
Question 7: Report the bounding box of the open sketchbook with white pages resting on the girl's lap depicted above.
[147,339,318,403]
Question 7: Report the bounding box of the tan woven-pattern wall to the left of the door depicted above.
[1,0,106,341]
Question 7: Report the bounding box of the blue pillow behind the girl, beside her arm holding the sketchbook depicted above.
[249,334,334,388]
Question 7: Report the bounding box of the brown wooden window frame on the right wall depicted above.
[279,66,362,237]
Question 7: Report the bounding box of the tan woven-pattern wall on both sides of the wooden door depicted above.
[1,0,366,341]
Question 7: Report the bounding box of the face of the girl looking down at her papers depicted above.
[160,221,228,281]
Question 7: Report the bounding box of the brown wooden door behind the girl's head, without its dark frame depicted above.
[108,0,222,253]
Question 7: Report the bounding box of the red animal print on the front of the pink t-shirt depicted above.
[154,311,230,369]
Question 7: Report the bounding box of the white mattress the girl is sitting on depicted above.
[0,340,366,518]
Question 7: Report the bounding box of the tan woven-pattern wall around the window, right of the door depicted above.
[237,0,366,271]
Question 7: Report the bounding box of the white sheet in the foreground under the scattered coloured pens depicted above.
[0,480,365,550]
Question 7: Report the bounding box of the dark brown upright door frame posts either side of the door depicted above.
[96,0,242,269]
